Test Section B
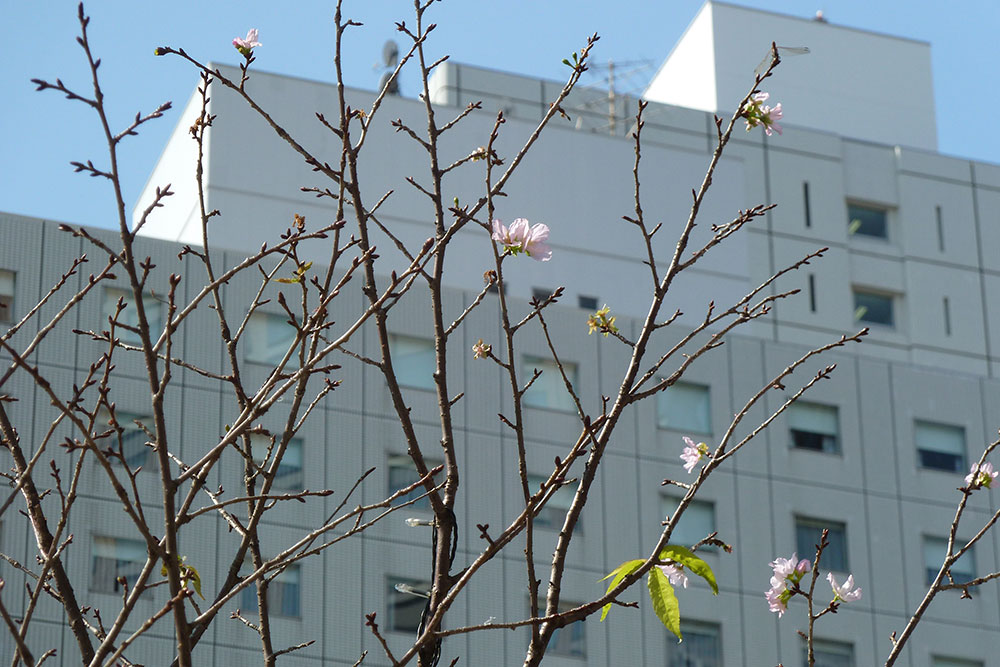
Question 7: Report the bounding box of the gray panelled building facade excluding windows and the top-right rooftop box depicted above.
[0,7,1000,667]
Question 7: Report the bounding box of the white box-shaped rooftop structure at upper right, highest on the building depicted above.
[644,1,937,150]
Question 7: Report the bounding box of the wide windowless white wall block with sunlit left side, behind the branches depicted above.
[137,64,750,330]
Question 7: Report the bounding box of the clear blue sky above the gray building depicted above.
[0,0,1000,227]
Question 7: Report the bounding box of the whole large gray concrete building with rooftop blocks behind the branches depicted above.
[0,2,1000,667]
